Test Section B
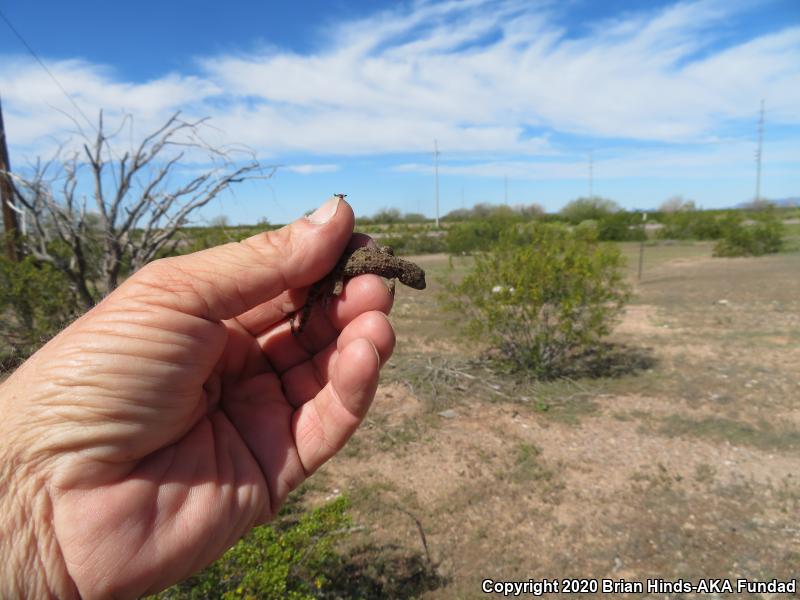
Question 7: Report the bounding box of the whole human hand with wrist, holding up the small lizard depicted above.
[0,198,394,597]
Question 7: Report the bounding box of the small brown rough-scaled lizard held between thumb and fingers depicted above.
[292,246,425,335]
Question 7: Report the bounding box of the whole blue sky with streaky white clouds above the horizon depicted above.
[0,0,800,223]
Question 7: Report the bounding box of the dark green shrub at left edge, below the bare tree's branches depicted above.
[0,257,79,367]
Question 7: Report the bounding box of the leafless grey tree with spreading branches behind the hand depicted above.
[5,112,275,308]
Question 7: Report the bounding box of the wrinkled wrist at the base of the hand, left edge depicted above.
[0,381,78,598]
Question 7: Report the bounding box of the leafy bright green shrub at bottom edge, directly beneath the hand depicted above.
[155,496,350,600]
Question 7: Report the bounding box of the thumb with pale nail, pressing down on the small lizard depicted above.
[119,196,355,321]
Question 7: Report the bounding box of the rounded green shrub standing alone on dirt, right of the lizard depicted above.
[447,223,628,379]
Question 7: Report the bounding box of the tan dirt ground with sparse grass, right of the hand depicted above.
[305,244,800,598]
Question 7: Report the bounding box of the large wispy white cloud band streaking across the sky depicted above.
[0,0,800,162]
